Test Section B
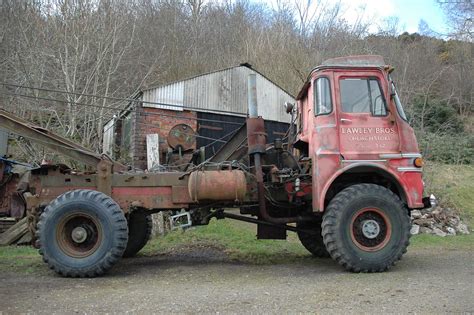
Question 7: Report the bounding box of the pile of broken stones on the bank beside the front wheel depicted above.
[411,206,470,237]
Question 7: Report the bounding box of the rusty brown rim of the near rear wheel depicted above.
[56,212,102,258]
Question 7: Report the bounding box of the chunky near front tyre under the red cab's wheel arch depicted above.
[322,184,410,272]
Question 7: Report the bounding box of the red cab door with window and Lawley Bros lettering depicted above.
[335,71,400,160]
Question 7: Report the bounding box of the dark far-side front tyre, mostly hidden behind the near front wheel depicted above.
[297,218,330,258]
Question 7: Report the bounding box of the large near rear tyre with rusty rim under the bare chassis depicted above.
[37,190,128,277]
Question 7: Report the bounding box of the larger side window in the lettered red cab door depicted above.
[339,78,387,116]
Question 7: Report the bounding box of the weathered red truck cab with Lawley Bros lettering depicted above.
[296,56,424,211]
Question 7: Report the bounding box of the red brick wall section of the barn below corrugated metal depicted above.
[130,106,197,169]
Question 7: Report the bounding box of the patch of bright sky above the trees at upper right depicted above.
[341,0,447,34]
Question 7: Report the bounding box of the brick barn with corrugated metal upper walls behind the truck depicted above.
[103,64,295,169]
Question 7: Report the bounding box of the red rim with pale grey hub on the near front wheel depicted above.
[350,208,392,252]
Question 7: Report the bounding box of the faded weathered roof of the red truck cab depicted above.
[296,55,385,100]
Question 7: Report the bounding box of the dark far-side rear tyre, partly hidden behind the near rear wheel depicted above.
[123,211,153,258]
